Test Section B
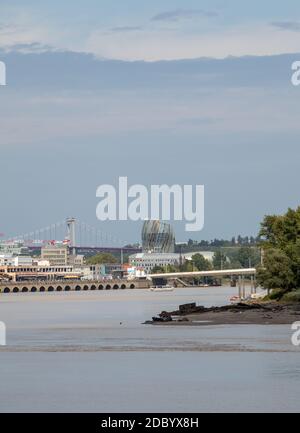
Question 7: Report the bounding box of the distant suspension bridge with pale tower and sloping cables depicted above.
[1,218,141,254]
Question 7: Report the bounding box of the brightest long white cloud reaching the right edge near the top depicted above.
[84,25,300,61]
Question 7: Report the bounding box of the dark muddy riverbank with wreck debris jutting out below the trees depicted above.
[145,303,300,326]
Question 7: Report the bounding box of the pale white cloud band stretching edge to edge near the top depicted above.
[0,6,300,61]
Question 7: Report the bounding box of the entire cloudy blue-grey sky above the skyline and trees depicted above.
[0,0,300,242]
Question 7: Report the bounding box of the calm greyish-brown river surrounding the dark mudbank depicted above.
[0,287,300,412]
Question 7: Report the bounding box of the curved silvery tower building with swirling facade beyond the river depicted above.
[142,221,175,253]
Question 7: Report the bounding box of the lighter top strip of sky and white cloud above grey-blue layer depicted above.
[0,0,300,61]
